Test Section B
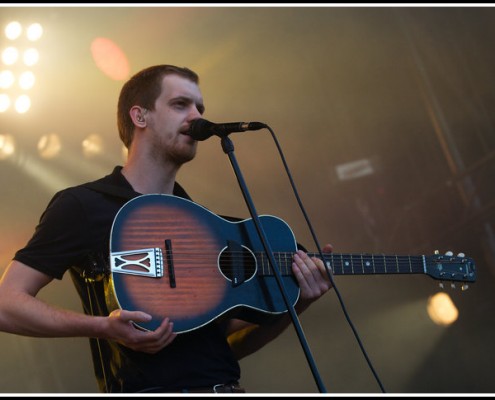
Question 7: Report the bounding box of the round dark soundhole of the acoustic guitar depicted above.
[218,244,256,286]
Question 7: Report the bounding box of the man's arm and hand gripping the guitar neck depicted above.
[227,244,332,360]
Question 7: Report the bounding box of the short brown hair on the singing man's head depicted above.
[117,64,199,148]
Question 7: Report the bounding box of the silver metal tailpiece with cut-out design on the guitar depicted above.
[110,247,163,278]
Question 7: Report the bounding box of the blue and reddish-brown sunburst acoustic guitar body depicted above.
[110,194,299,333]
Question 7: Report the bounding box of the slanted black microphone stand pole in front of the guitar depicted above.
[221,135,326,393]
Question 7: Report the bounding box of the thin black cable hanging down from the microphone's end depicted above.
[265,124,385,393]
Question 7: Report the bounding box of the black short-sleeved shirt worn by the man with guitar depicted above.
[14,167,240,393]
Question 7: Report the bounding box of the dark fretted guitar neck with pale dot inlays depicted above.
[258,252,426,275]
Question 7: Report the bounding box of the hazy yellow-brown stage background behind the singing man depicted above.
[0,6,495,393]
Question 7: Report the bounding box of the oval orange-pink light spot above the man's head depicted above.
[91,38,130,81]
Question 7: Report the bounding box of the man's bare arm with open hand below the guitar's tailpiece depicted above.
[0,261,175,353]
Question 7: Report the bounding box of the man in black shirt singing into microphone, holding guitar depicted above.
[0,65,332,393]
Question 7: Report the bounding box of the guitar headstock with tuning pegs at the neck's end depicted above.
[425,251,476,289]
